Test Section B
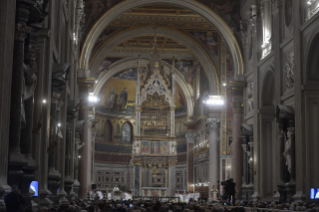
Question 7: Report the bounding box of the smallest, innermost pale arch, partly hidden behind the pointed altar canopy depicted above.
[94,58,194,118]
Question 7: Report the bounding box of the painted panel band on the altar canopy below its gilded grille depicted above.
[141,141,170,155]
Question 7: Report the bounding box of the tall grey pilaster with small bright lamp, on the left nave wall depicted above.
[32,29,52,208]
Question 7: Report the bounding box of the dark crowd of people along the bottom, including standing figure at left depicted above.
[4,186,319,212]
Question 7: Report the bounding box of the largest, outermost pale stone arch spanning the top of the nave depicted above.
[79,0,244,79]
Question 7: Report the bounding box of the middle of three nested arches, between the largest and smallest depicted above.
[89,27,220,94]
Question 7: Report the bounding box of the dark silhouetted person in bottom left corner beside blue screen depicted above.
[4,185,25,212]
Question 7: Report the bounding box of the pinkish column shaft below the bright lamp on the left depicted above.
[79,105,93,198]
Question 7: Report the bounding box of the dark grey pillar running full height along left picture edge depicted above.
[0,0,16,207]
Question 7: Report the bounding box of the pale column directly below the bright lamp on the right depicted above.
[206,118,220,199]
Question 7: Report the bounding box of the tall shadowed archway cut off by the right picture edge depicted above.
[304,27,319,201]
